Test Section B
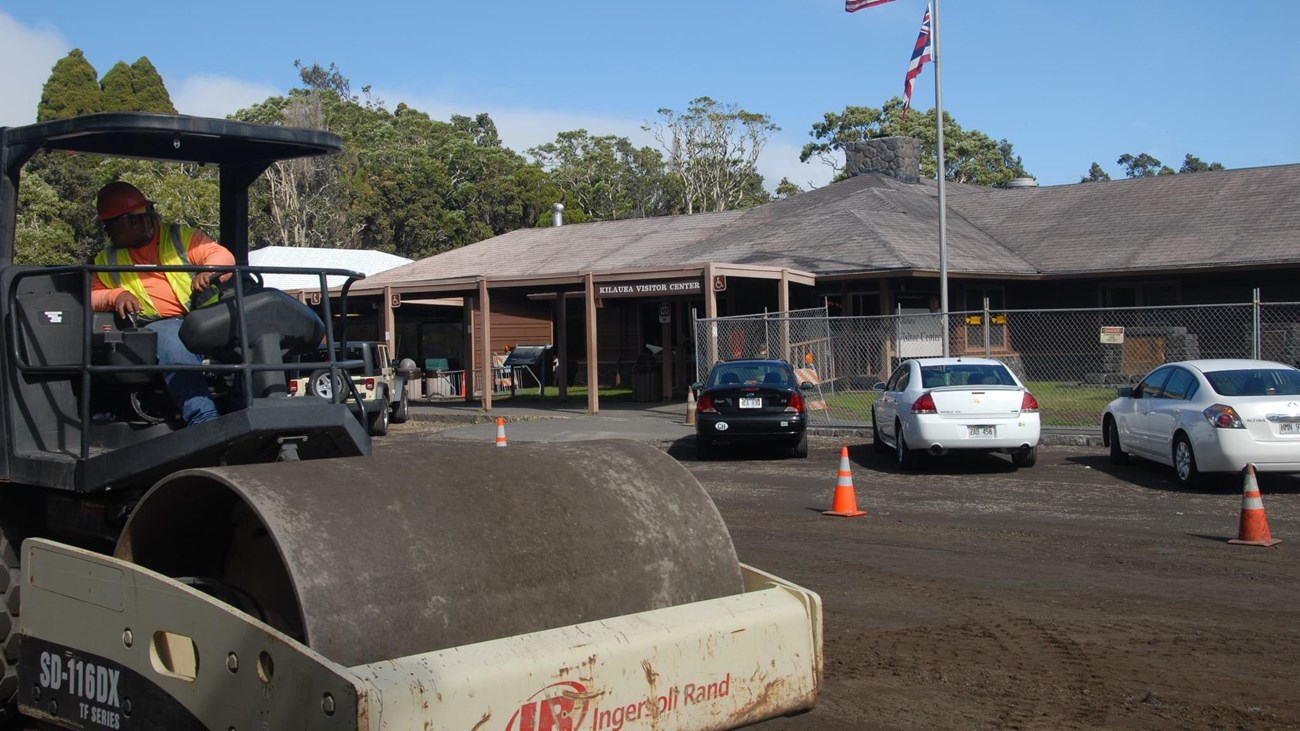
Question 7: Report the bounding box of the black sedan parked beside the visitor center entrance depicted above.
[694,360,813,459]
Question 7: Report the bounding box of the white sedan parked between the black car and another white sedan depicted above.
[871,358,1041,470]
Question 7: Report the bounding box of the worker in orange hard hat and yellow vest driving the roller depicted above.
[91,181,235,425]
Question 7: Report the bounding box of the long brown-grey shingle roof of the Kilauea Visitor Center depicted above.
[367,165,1300,286]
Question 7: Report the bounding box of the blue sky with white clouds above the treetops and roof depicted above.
[0,0,1300,189]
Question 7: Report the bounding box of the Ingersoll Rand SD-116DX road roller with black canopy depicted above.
[0,113,822,731]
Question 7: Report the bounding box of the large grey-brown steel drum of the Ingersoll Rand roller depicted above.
[117,440,742,666]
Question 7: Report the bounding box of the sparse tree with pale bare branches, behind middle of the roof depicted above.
[641,96,780,213]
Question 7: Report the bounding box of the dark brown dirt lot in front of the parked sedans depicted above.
[395,424,1300,730]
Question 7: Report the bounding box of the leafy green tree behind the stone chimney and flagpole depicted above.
[800,96,1028,186]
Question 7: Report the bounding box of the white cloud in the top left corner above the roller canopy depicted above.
[0,12,69,126]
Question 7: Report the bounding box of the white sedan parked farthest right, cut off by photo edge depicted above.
[1101,359,1300,486]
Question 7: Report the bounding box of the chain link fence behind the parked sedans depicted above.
[696,302,1300,429]
